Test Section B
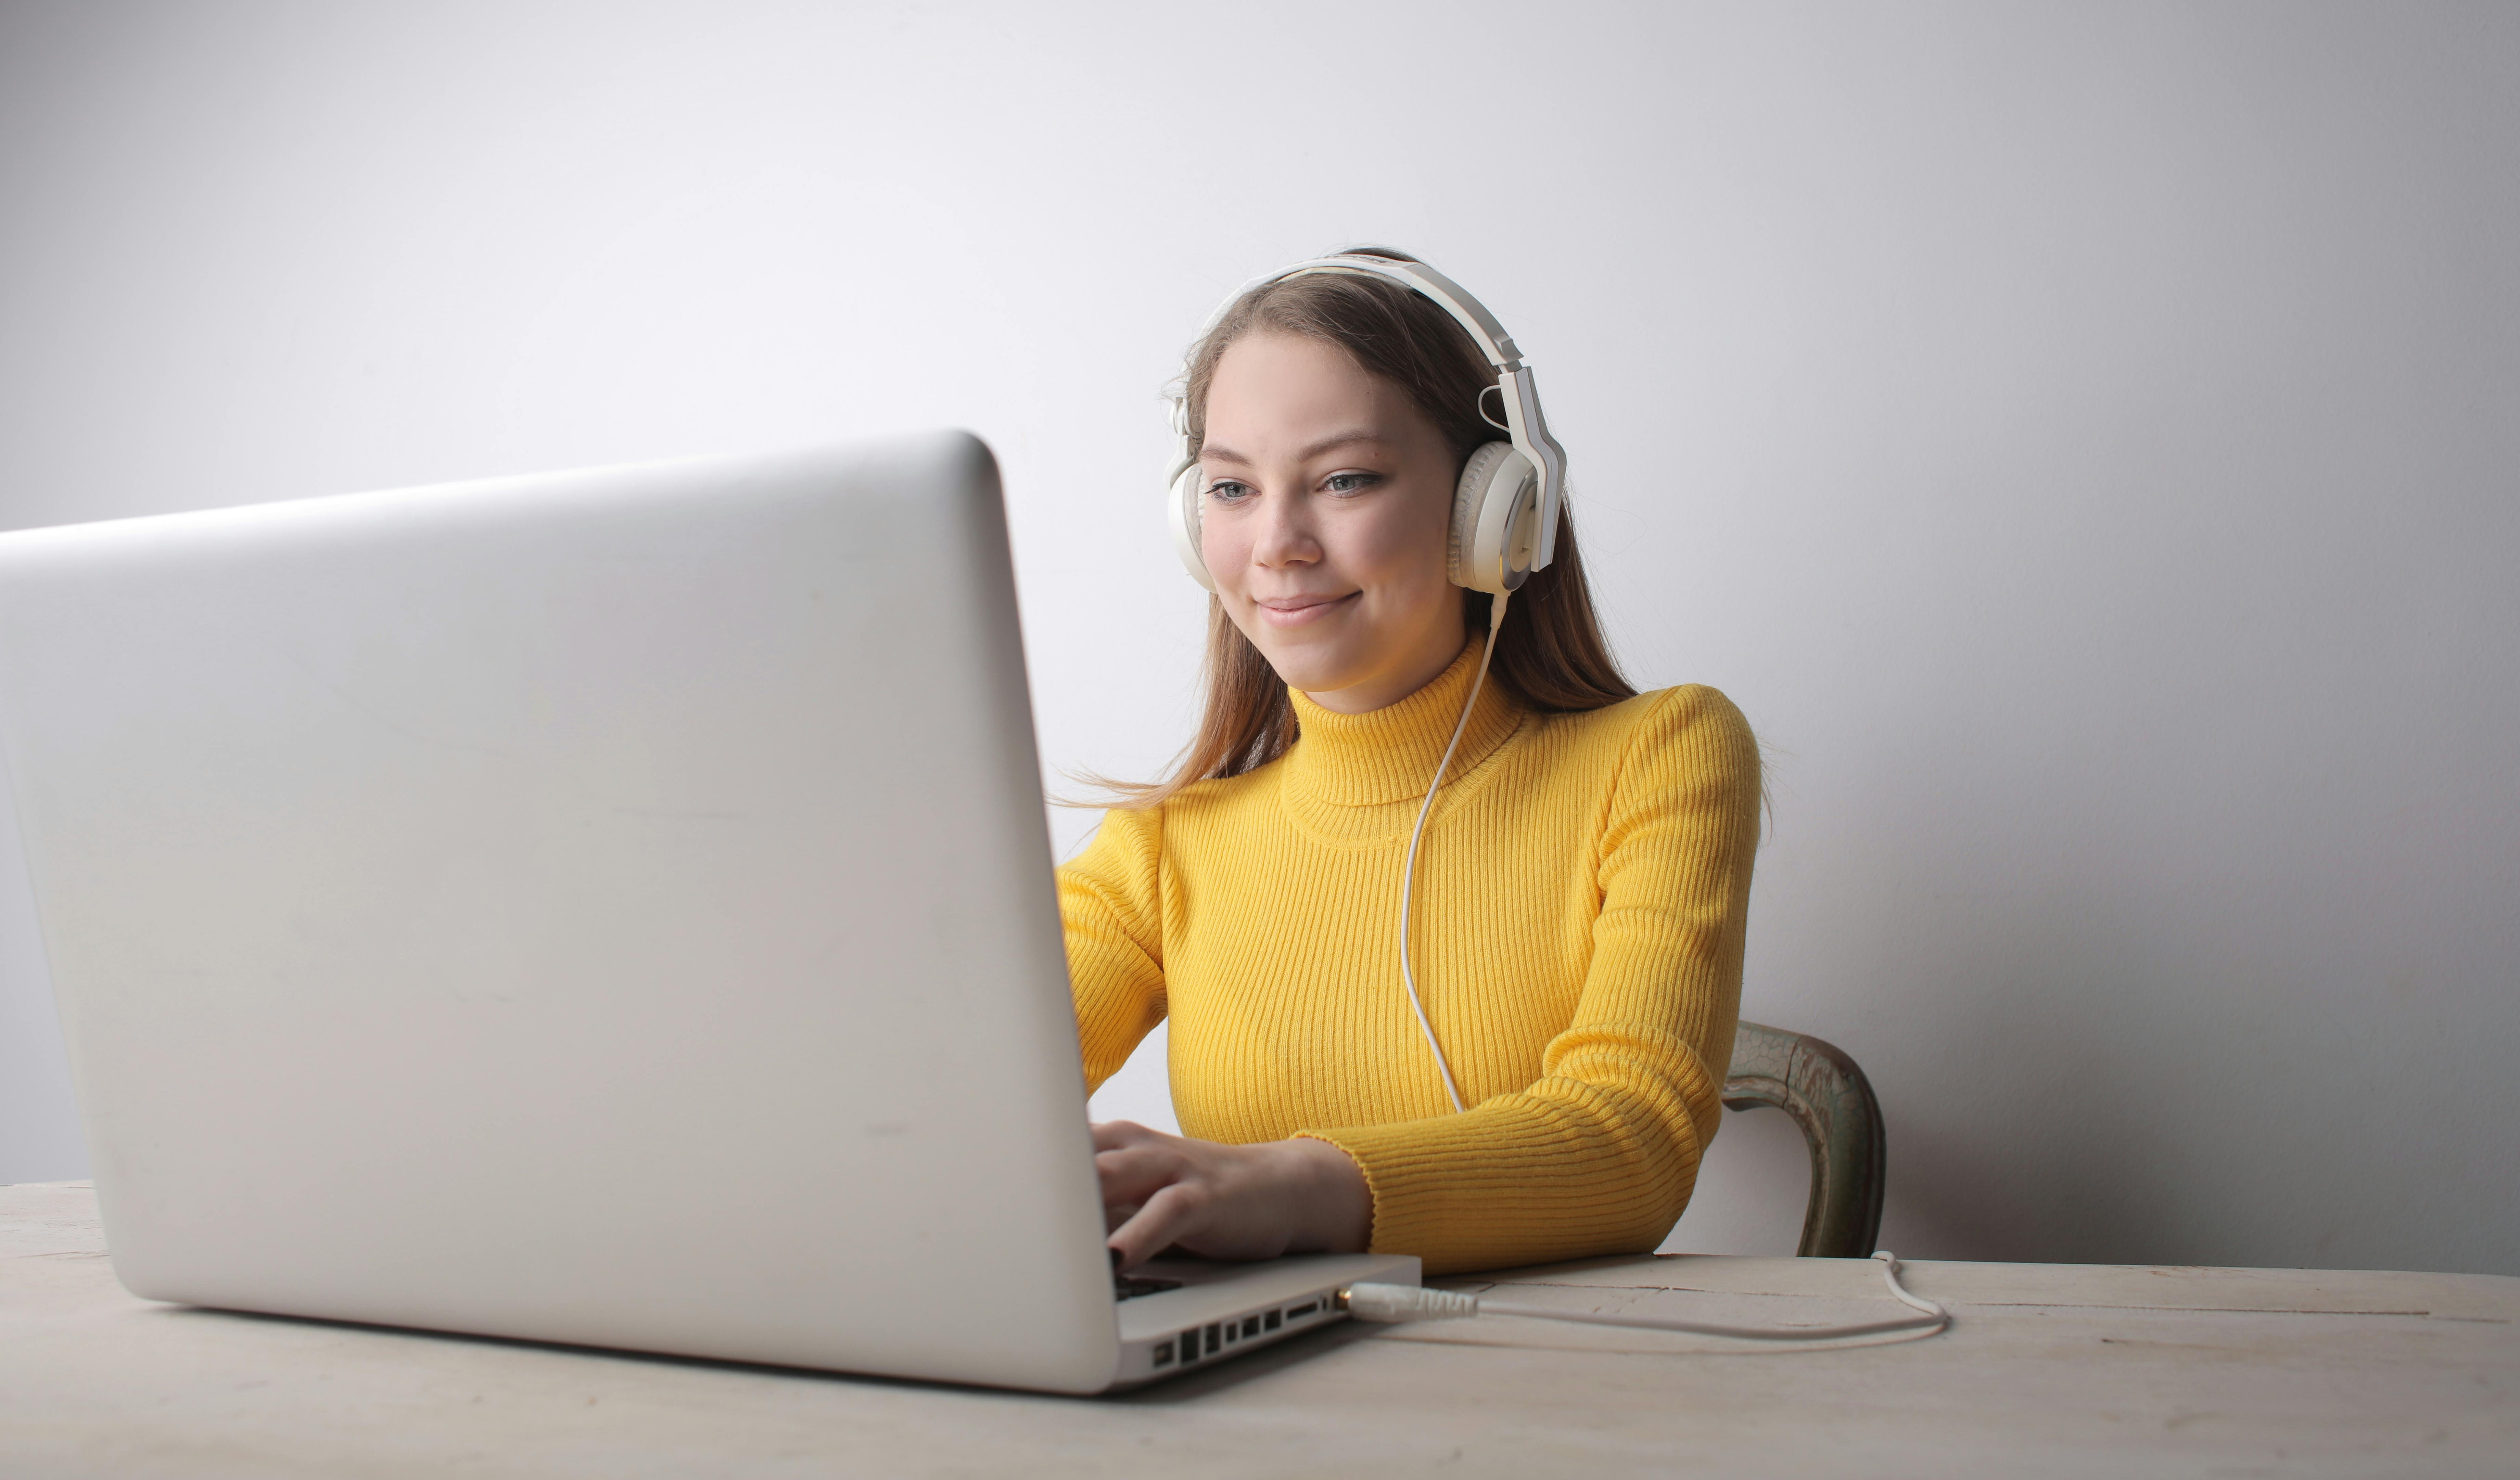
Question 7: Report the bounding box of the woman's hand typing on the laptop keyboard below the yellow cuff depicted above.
[1094,1119,1373,1268]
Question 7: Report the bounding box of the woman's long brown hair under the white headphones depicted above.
[1101,247,1636,807]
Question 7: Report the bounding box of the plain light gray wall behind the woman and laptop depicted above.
[0,2,2520,1273]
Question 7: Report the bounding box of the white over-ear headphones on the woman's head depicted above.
[1164,252,1567,595]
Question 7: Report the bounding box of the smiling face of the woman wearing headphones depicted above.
[1199,330,1464,713]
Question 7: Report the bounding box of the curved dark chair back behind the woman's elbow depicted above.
[1724,1024,1885,1258]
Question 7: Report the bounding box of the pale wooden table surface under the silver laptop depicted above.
[0,1183,2520,1480]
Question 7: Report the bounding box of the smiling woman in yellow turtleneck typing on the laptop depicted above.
[1058,252,1759,1273]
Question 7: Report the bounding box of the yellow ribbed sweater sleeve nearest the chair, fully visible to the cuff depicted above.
[1303,688,1759,1273]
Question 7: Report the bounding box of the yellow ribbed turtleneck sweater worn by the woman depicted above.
[1058,643,1759,1273]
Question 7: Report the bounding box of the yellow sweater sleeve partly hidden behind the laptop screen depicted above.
[1058,807,1164,1094]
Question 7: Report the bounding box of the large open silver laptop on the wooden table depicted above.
[0,434,1416,1392]
